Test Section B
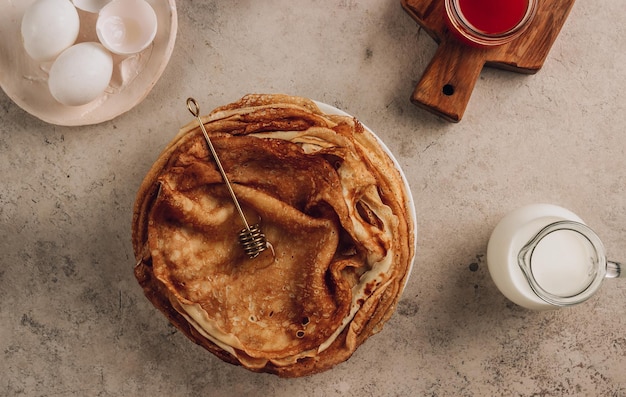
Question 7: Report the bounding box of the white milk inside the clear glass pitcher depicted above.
[487,204,588,310]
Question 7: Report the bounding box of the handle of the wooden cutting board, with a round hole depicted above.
[411,40,490,122]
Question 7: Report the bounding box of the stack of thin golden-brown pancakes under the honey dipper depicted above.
[133,95,415,377]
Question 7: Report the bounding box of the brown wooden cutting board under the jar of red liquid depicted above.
[401,0,574,122]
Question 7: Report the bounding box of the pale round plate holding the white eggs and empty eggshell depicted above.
[0,0,178,126]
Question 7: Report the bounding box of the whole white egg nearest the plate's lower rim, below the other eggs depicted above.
[48,42,113,106]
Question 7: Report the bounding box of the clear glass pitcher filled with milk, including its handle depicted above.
[487,204,624,310]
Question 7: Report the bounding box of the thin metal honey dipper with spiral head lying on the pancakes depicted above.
[187,98,273,259]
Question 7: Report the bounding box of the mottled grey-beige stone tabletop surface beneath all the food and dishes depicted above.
[0,0,626,396]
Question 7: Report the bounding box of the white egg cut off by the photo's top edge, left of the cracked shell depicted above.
[22,0,80,61]
